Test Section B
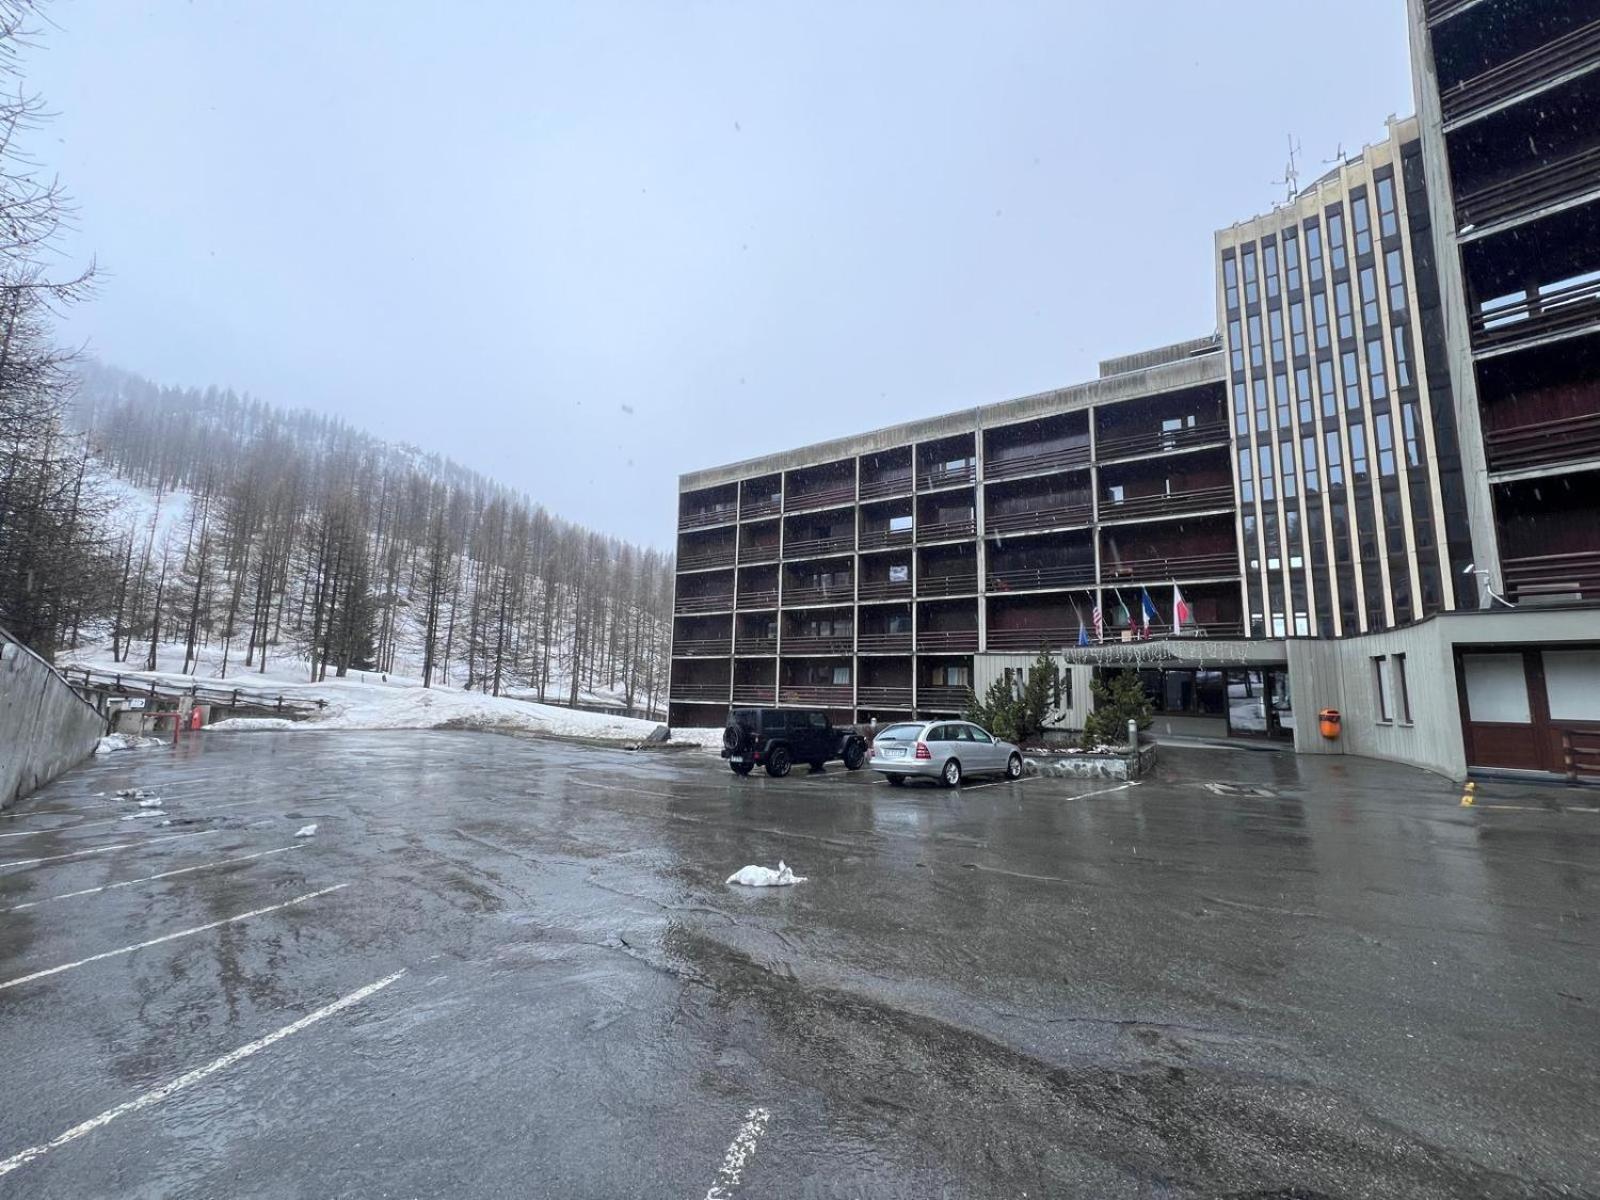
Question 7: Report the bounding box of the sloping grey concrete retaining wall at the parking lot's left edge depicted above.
[0,629,106,808]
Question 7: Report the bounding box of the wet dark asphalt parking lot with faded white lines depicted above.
[0,733,1600,1200]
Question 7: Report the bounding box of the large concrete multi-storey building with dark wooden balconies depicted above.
[670,0,1600,790]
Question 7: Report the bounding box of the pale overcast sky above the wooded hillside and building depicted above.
[29,0,1411,547]
